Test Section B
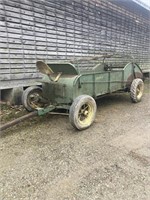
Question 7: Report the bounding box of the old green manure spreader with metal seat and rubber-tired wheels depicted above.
[22,55,144,130]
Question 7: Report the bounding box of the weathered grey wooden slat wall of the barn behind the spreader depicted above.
[0,0,150,89]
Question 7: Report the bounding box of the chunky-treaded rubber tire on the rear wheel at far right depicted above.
[130,78,144,103]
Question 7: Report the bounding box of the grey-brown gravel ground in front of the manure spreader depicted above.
[0,82,150,200]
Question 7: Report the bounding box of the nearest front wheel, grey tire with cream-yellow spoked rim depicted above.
[69,95,97,130]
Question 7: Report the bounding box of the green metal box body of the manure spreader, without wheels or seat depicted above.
[35,55,143,115]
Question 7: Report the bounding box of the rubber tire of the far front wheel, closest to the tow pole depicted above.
[22,86,42,112]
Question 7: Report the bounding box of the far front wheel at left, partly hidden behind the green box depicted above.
[22,86,43,111]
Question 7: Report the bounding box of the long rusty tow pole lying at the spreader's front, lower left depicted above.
[0,111,38,132]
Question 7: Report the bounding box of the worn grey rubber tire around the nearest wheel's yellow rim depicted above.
[69,95,97,130]
